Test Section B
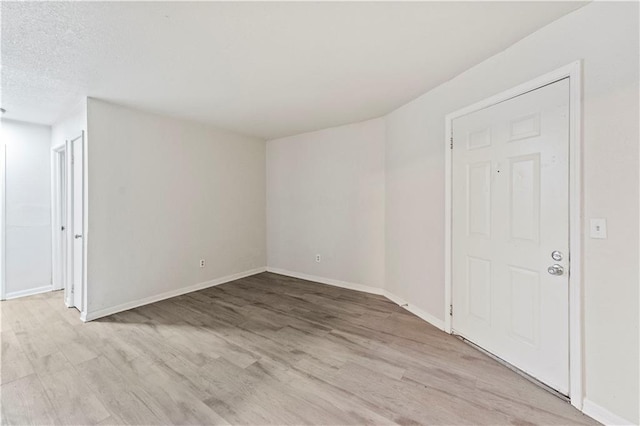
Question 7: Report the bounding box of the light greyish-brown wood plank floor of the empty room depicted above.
[0,273,596,425]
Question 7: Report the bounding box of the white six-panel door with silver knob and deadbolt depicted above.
[452,79,569,395]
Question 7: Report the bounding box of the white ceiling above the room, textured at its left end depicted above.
[1,1,584,138]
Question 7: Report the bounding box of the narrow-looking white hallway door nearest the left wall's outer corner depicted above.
[71,134,84,311]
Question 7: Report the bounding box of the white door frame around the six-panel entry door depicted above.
[444,60,584,410]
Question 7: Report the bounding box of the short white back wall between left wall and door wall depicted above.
[267,119,385,288]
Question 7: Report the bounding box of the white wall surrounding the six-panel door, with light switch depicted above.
[385,2,640,423]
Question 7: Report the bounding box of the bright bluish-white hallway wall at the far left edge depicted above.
[2,120,51,298]
